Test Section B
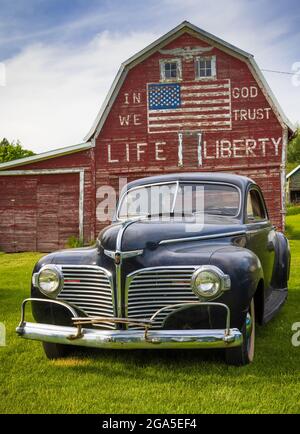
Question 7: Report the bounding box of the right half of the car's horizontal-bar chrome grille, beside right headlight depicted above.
[126,266,199,329]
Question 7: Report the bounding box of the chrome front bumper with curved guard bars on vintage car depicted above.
[16,298,243,349]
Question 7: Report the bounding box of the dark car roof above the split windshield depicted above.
[125,172,255,190]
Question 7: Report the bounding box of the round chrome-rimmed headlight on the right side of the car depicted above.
[192,266,230,299]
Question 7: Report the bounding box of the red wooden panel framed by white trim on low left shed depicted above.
[0,174,79,252]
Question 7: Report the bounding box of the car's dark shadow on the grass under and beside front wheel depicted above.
[47,304,299,383]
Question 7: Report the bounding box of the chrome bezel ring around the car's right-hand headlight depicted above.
[191,265,231,301]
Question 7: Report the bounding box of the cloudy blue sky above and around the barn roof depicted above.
[0,0,300,153]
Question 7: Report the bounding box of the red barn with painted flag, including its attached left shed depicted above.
[0,22,293,252]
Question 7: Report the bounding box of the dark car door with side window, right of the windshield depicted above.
[245,185,276,297]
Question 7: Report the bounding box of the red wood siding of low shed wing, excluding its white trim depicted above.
[0,149,95,252]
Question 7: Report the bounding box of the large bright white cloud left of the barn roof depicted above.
[0,32,155,152]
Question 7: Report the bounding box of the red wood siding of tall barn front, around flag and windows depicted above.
[95,33,283,230]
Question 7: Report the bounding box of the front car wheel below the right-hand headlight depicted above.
[225,299,255,366]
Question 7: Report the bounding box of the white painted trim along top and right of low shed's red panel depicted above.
[0,168,84,239]
